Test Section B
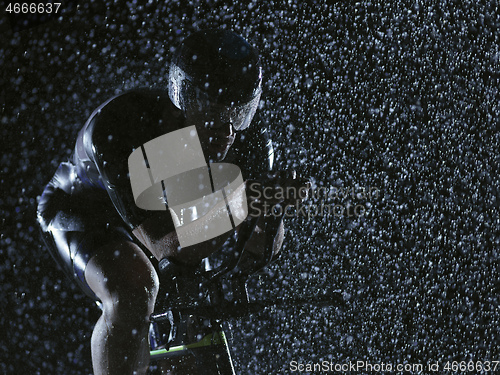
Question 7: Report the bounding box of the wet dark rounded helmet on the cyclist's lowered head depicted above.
[168,30,262,130]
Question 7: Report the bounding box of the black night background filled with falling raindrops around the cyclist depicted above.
[0,0,500,374]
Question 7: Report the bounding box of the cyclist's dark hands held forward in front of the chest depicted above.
[246,171,311,216]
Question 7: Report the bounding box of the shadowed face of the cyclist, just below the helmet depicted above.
[186,104,235,161]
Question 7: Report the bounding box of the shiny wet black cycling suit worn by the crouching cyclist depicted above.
[38,89,274,299]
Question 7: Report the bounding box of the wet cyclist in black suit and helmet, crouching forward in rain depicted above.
[38,30,307,375]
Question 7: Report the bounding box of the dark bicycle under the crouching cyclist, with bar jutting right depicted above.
[146,207,343,375]
